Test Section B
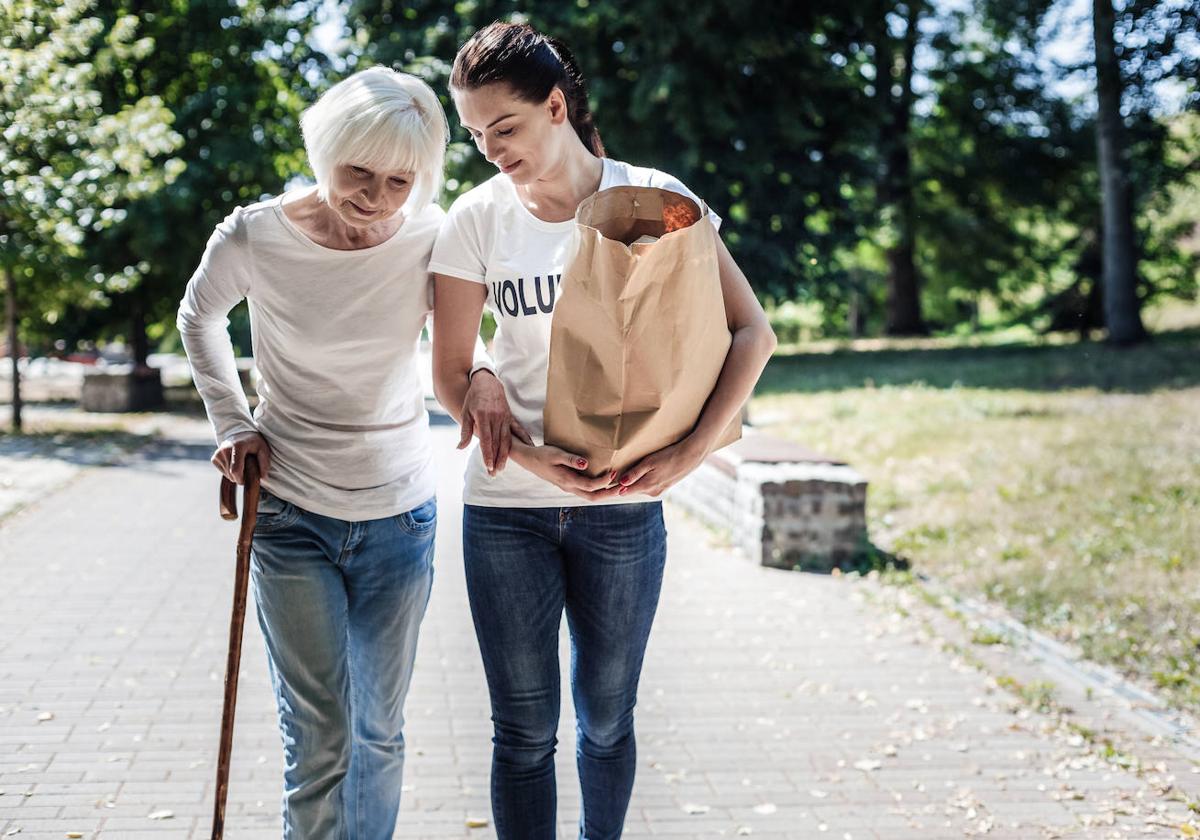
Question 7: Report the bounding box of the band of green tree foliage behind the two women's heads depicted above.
[0,0,1200,355]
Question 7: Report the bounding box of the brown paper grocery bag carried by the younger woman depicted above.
[542,186,742,475]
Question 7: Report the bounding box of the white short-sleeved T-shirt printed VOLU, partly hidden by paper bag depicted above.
[430,158,721,508]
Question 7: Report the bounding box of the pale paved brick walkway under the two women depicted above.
[0,425,1200,840]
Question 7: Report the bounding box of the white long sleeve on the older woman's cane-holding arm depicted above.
[175,208,258,443]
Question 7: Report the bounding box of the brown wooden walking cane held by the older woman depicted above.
[212,455,258,840]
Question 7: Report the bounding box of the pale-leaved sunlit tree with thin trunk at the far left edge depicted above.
[0,0,181,432]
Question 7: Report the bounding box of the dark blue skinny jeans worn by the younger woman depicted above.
[463,502,666,840]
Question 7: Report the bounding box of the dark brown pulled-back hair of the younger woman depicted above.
[450,20,605,157]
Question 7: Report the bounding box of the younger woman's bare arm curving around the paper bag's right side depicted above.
[620,233,775,496]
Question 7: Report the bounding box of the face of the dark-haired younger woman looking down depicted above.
[451,83,569,184]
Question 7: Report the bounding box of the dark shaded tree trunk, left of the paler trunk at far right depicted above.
[875,0,929,335]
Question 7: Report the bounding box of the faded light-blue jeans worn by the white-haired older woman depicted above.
[251,492,437,840]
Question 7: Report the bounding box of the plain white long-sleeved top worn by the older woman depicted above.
[178,196,445,521]
